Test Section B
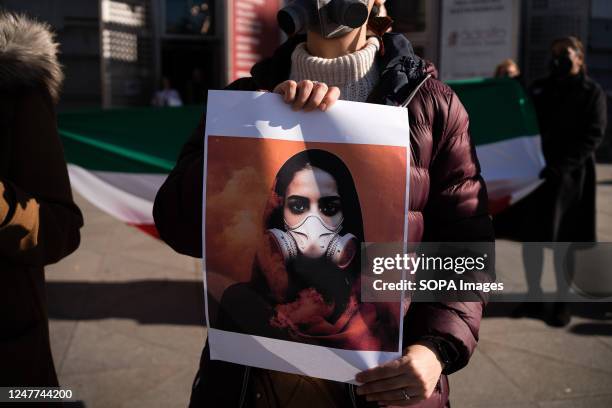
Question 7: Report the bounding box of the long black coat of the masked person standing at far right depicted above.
[530,74,607,242]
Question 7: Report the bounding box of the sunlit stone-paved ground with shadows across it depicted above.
[47,166,612,408]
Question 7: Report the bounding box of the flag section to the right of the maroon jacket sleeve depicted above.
[449,79,545,215]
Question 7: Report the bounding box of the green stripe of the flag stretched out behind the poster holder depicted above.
[58,79,539,174]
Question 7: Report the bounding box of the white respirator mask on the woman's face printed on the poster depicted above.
[269,215,357,269]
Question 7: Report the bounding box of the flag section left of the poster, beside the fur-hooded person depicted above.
[58,106,202,236]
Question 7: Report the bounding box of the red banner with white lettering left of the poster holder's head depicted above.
[226,0,283,83]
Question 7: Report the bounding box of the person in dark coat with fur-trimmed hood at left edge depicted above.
[0,13,83,387]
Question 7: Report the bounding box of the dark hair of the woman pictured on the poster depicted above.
[267,149,364,242]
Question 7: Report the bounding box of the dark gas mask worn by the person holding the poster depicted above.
[277,0,368,38]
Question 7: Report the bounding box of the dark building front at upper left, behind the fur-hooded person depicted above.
[0,0,226,109]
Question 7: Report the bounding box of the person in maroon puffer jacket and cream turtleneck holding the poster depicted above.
[153,0,494,408]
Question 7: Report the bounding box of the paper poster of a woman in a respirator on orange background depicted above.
[203,91,409,382]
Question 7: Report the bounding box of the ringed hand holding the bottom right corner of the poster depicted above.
[355,343,442,407]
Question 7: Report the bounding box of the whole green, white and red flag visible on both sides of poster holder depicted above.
[59,80,544,236]
